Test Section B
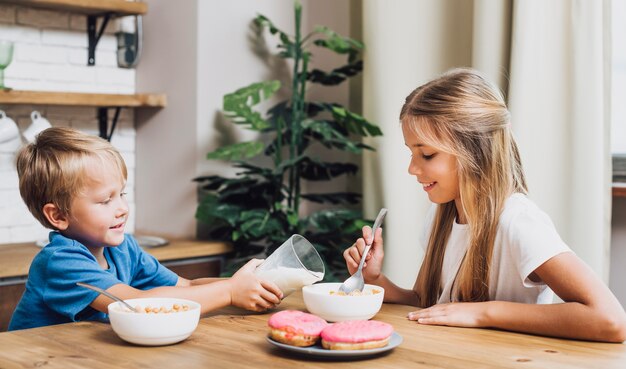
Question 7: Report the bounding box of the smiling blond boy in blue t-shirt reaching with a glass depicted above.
[9,127,282,330]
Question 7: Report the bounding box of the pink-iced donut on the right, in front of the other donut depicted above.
[321,320,393,350]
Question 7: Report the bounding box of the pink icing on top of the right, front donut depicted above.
[322,320,393,343]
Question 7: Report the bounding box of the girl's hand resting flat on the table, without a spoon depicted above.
[407,302,488,327]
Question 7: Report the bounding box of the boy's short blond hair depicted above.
[16,127,128,229]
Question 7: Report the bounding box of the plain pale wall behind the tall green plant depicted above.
[137,0,350,237]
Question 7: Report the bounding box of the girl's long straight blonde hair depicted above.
[400,68,528,307]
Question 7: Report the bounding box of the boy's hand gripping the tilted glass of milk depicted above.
[229,259,283,311]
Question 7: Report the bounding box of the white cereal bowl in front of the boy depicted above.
[108,297,200,346]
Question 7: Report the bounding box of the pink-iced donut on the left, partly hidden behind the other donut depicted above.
[267,310,328,347]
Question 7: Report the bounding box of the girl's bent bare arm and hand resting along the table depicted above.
[409,252,626,342]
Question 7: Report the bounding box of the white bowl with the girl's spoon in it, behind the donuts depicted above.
[302,283,385,322]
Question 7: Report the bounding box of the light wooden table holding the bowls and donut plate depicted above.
[0,293,626,369]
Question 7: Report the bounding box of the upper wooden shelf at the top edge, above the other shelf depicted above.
[0,0,148,16]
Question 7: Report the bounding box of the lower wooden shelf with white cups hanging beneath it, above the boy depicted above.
[0,90,167,108]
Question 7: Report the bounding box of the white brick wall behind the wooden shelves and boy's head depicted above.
[0,4,135,244]
